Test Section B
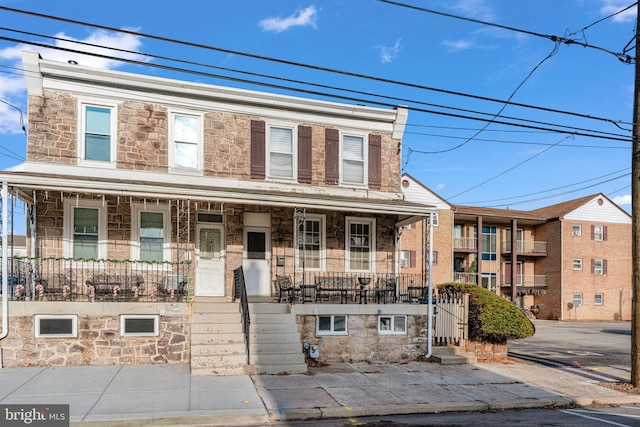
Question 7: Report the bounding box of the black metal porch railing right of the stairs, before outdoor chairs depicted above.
[272,272,428,304]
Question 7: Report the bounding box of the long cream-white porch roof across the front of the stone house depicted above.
[0,163,435,220]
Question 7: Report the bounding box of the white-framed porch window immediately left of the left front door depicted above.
[131,203,171,262]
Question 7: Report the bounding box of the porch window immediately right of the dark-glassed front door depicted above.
[296,214,325,271]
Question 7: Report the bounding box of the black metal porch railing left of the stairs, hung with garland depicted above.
[7,257,192,302]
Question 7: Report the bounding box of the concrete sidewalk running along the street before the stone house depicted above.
[0,362,640,427]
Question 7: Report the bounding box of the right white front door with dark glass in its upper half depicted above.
[242,227,271,296]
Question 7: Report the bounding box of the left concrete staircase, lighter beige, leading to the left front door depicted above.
[191,298,249,375]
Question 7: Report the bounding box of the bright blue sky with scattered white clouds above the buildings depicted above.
[0,0,636,229]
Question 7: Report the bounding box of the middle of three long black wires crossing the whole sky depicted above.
[0,27,623,144]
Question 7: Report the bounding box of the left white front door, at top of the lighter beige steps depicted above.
[195,224,225,297]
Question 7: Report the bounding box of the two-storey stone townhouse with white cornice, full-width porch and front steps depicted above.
[0,52,444,374]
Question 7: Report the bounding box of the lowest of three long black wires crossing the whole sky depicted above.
[0,34,631,142]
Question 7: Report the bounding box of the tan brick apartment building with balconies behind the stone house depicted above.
[400,175,631,320]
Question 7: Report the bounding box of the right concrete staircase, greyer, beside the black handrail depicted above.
[249,303,307,375]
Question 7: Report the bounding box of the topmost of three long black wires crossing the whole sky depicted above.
[0,6,632,127]
